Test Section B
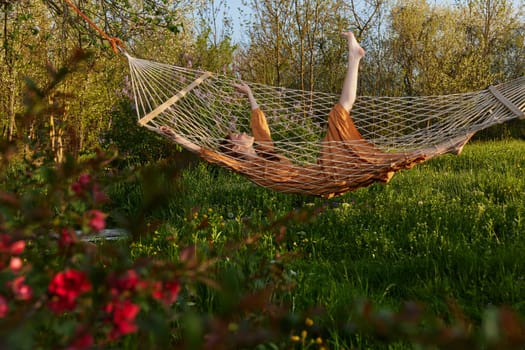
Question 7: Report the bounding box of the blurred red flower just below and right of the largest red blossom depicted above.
[106,300,140,340]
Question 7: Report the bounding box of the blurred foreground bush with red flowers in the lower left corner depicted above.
[0,157,188,349]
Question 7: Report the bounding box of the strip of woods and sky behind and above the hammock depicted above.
[0,0,525,160]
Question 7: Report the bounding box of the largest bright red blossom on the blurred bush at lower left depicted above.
[48,270,91,314]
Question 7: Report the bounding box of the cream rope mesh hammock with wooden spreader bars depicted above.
[126,54,525,197]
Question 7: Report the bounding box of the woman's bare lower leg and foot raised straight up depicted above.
[339,32,365,112]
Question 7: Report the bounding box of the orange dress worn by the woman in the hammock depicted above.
[200,104,462,198]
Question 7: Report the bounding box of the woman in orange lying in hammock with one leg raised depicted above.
[161,32,470,198]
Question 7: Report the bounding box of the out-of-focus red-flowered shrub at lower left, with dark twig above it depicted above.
[0,56,208,349]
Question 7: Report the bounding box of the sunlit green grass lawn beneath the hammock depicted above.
[107,141,525,346]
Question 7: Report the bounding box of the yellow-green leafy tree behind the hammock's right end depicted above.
[390,0,523,95]
